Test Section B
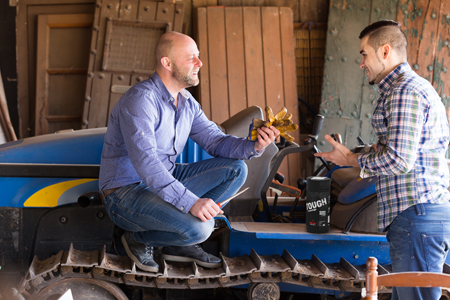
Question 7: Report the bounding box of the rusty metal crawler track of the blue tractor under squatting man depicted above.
[14,245,398,300]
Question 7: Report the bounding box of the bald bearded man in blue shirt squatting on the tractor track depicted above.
[99,32,279,272]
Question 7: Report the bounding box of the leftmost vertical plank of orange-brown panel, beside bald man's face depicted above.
[195,7,211,119]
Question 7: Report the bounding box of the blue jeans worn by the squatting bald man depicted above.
[105,158,247,247]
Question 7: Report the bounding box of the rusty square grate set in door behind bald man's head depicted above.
[103,20,171,74]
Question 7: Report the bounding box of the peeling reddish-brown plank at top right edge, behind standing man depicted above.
[432,1,450,103]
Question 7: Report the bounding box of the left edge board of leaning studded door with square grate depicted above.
[83,0,120,128]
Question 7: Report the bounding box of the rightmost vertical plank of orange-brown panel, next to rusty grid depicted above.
[280,7,301,186]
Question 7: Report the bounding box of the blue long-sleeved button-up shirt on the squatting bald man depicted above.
[99,72,264,213]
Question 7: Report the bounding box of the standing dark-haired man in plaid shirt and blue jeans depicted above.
[316,20,450,300]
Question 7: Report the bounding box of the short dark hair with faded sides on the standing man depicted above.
[359,20,408,57]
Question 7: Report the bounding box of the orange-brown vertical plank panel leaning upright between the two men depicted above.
[196,6,300,184]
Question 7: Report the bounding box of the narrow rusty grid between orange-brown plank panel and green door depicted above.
[294,23,326,131]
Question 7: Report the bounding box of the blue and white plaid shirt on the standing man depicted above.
[358,63,450,231]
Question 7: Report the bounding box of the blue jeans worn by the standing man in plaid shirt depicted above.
[386,203,450,300]
